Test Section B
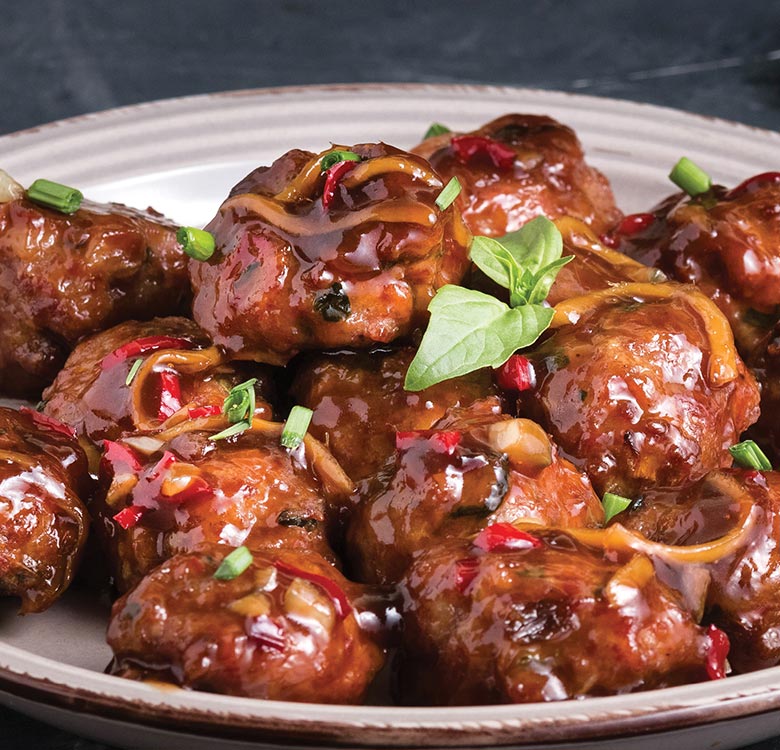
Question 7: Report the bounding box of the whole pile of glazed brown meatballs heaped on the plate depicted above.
[0,115,780,705]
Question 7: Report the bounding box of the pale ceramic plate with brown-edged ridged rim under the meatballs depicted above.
[0,85,780,750]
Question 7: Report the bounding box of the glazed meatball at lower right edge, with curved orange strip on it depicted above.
[619,469,780,672]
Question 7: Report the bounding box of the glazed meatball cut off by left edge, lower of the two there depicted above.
[0,407,89,613]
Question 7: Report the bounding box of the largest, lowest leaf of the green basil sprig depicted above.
[404,284,553,391]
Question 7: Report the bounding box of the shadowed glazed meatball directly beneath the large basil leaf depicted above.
[292,347,495,482]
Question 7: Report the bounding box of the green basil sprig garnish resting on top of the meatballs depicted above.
[404,216,573,391]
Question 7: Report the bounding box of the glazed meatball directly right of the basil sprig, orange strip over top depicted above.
[521,284,759,497]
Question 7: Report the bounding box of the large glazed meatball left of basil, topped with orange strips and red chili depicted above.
[189,143,470,364]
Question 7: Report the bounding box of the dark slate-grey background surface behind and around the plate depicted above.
[0,0,780,750]
